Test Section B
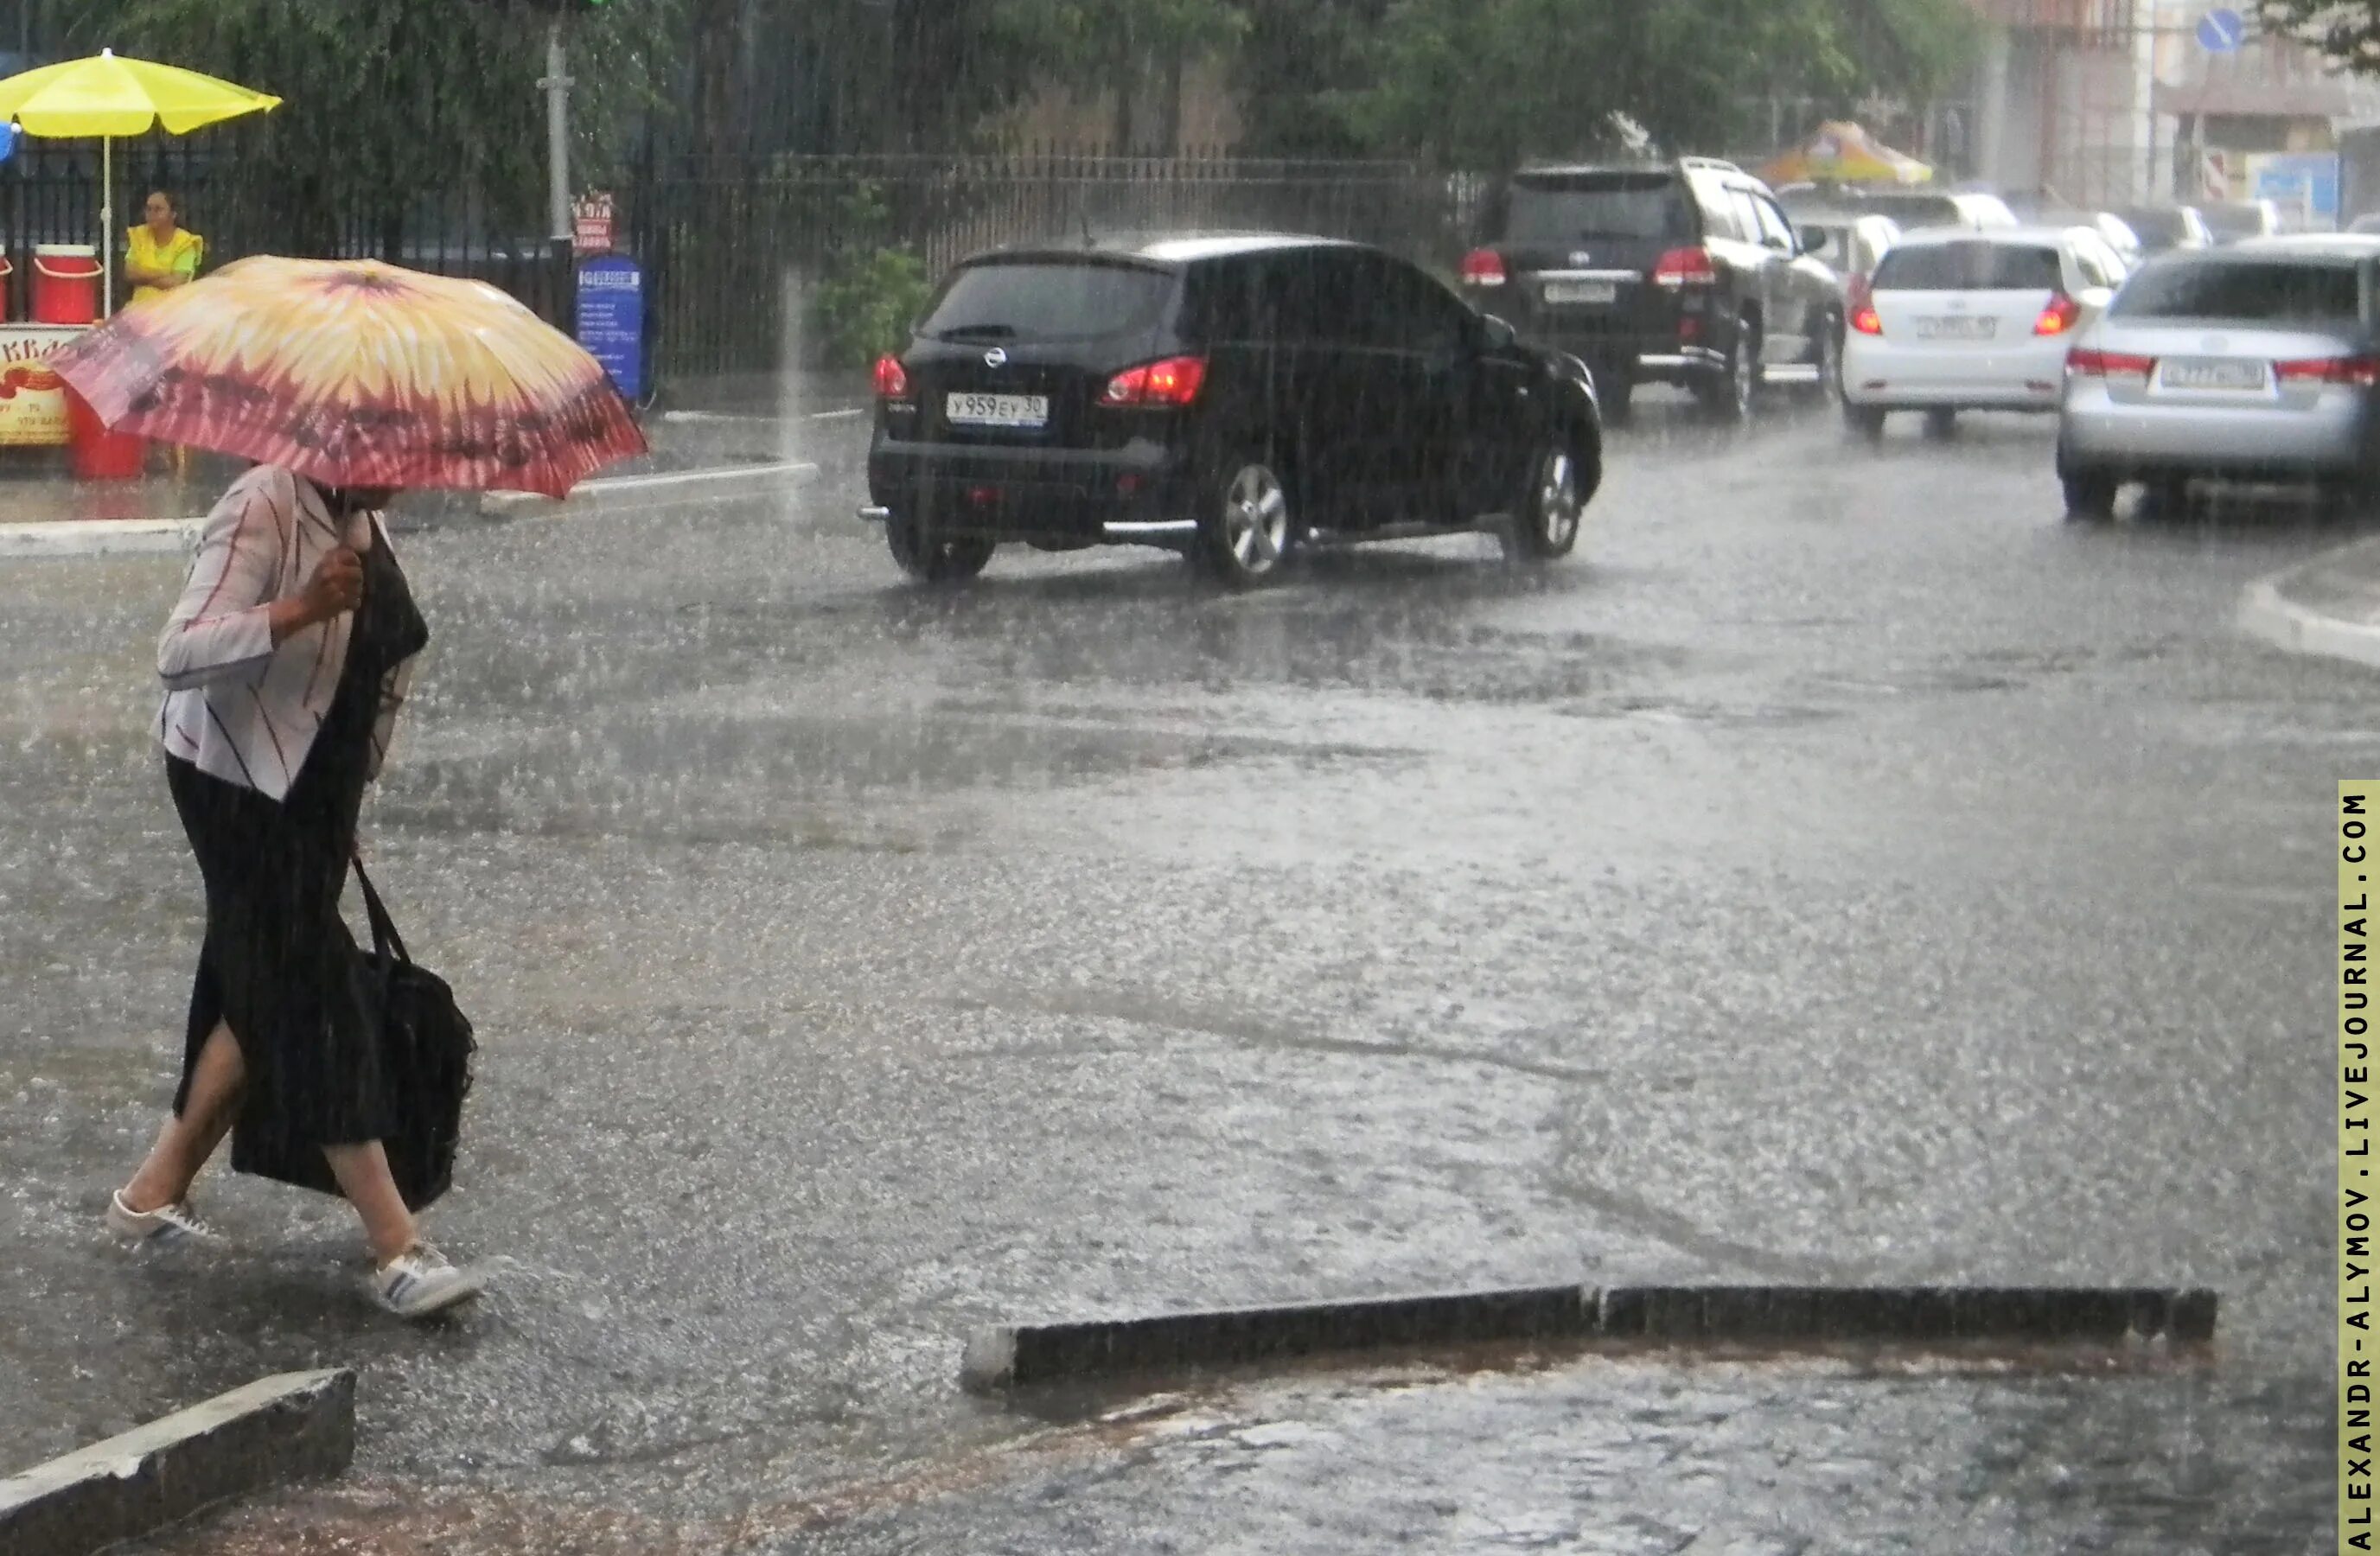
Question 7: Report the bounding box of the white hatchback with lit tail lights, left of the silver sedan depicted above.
[1842,226,2123,437]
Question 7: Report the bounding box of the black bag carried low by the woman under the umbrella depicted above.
[233,859,478,1211]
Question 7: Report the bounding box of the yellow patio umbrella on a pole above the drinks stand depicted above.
[0,48,281,312]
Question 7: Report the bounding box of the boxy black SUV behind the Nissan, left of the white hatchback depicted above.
[1464,157,1845,421]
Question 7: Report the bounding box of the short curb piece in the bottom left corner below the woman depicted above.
[0,1368,354,1556]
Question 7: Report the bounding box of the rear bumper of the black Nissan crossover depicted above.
[859,437,1197,545]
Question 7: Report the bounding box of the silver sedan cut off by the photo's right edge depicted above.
[2057,235,2380,519]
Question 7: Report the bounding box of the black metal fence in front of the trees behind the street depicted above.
[0,138,1480,397]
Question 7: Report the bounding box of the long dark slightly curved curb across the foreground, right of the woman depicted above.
[959,1285,2218,1394]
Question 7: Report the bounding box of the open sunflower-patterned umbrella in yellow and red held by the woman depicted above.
[50,254,645,497]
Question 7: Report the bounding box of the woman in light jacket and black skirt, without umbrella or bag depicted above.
[107,464,481,1318]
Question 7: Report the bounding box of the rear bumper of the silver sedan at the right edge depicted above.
[2058,380,2380,478]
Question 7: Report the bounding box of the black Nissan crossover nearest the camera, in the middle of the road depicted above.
[862,233,1602,585]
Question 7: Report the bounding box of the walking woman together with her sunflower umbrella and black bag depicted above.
[50,254,645,1318]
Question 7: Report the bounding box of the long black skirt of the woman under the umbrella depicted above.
[167,751,395,1170]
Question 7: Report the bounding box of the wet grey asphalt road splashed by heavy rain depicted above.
[0,387,2351,1556]
